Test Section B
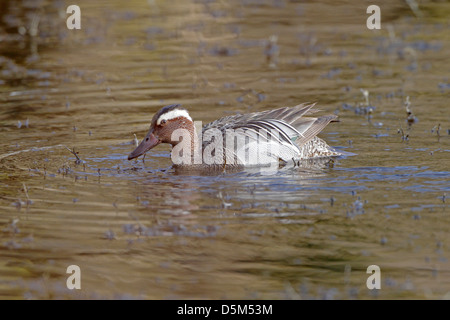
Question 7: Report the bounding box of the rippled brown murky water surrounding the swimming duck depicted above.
[0,0,450,299]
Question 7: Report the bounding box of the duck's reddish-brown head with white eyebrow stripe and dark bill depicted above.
[128,104,194,160]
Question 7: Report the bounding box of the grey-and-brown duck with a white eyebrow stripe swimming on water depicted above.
[128,103,342,168]
